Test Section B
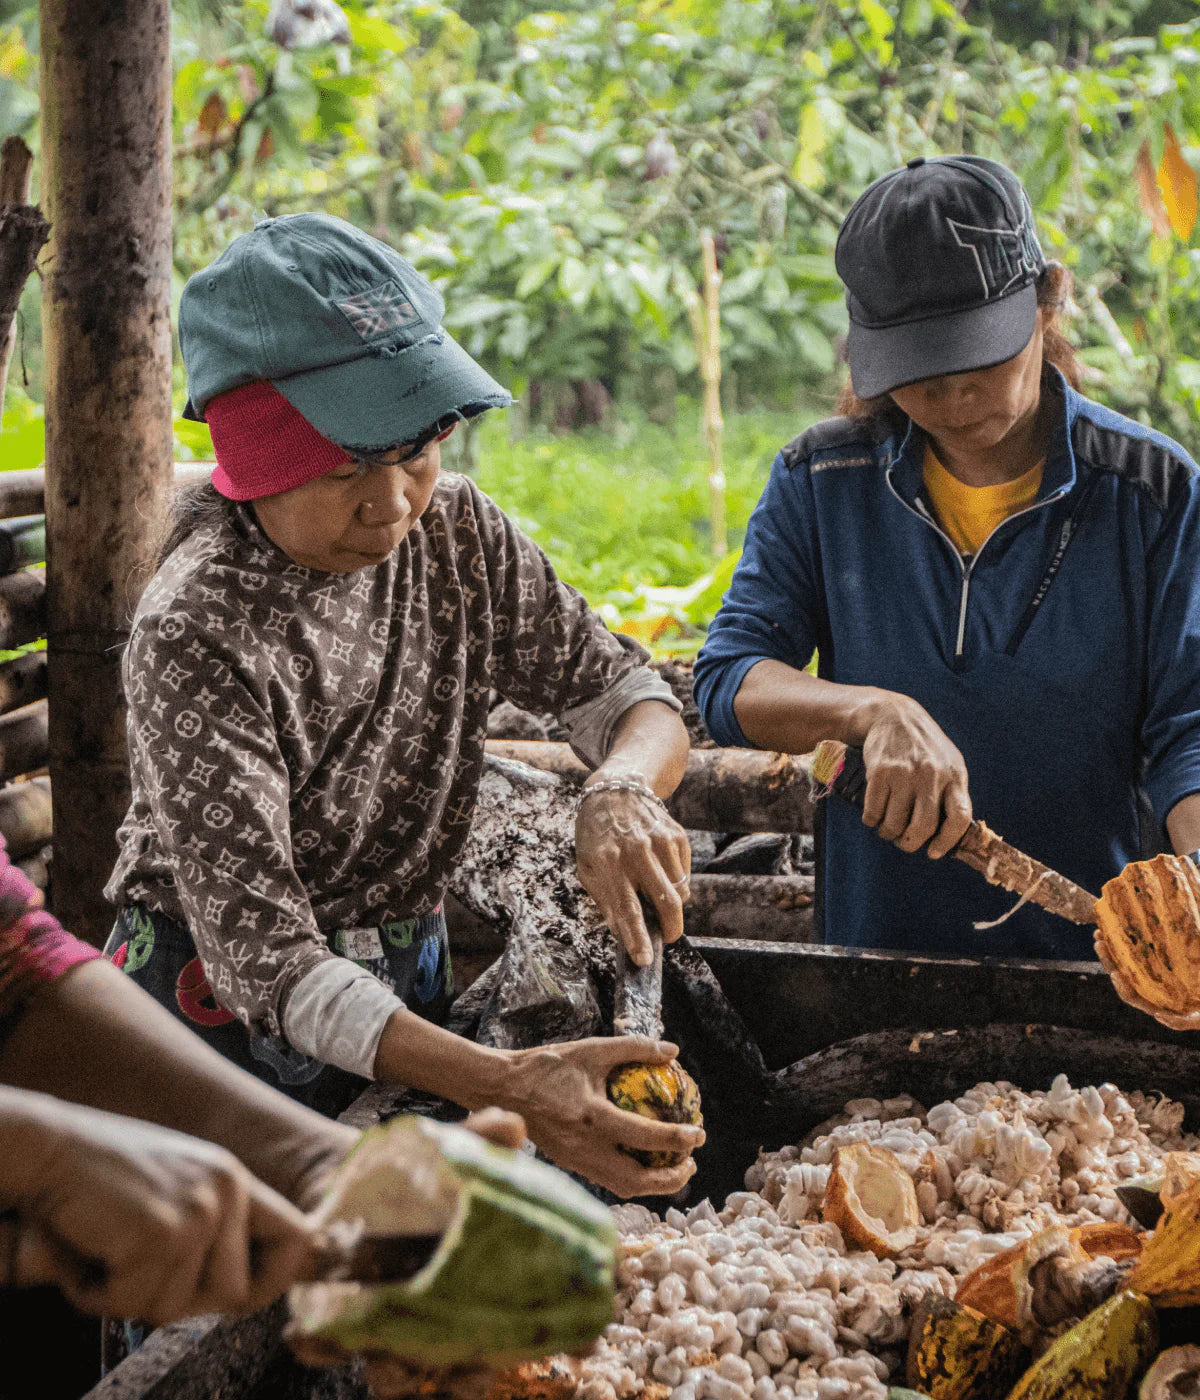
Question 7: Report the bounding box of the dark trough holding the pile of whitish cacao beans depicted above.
[84,938,1200,1400]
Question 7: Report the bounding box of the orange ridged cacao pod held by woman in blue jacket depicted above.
[1095,855,1200,1030]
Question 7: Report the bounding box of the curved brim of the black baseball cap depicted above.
[846,281,1038,399]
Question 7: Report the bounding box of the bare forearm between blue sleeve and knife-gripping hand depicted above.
[734,661,891,753]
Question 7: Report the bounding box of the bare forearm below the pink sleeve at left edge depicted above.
[0,962,357,1204]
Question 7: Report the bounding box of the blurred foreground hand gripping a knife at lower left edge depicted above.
[0,1091,311,1326]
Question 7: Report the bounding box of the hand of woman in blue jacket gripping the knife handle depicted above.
[863,692,972,860]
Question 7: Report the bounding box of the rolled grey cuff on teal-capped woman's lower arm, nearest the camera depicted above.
[283,958,403,1079]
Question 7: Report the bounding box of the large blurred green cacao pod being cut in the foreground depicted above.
[287,1117,618,1379]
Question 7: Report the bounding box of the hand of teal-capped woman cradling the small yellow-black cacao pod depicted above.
[504,1036,704,1197]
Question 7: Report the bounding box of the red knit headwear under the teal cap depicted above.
[204,379,350,501]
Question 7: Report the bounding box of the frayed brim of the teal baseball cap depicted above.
[272,330,512,452]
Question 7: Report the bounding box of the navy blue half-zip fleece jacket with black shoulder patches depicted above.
[696,374,1200,958]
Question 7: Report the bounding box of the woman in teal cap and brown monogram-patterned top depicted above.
[108,214,703,1194]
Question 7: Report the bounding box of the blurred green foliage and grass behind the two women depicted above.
[0,0,1200,638]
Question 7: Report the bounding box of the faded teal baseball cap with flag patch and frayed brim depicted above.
[179,214,512,452]
